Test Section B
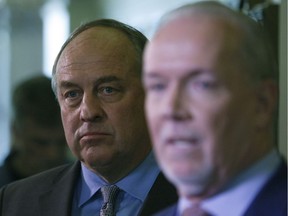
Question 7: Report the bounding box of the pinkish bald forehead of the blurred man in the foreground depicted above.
[144,15,237,71]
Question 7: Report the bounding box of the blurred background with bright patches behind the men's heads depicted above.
[0,0,287,164]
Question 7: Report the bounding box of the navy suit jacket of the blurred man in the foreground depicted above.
[154,161,287,216]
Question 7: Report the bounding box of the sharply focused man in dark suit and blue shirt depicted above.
[0,20,177,216]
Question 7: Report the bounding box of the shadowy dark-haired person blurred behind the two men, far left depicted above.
[0,75,69,187]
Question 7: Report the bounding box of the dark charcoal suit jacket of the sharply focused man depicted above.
[0,162,177,216]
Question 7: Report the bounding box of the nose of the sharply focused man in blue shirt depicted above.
[80,93,105,122]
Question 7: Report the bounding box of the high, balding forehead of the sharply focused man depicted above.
[56,26,136,71]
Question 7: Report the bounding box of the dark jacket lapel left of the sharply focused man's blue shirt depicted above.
[39,162,80,216]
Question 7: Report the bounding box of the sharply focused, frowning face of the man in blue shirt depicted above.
[57,27,151,181]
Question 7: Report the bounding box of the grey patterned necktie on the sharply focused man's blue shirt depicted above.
[100,185,120,216]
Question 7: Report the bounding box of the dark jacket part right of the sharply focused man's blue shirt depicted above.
[139,173,178,216]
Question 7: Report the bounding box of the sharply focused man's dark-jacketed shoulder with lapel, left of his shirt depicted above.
[0,162,80,216]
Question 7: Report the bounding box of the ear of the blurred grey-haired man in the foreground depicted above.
[256,79,278,128]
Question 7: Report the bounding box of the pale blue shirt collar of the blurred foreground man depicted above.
[178,150,281,216]
